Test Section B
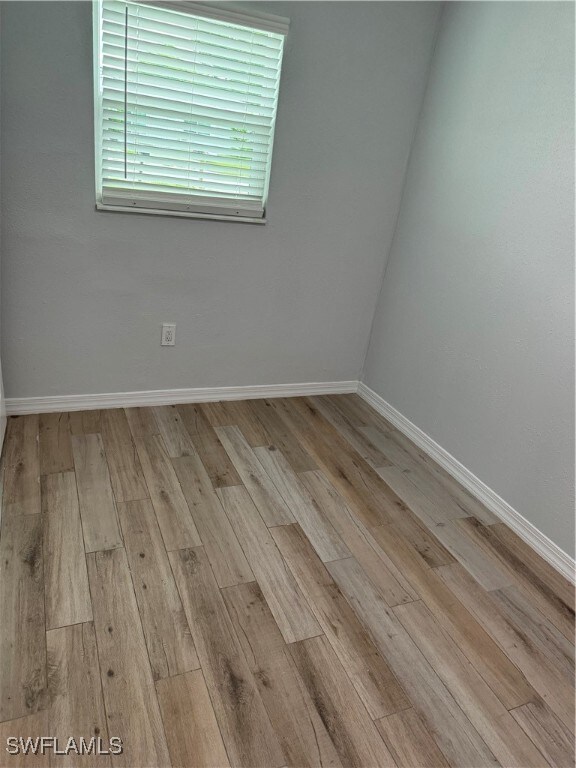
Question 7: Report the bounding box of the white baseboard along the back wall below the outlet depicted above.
[6,381,358,415]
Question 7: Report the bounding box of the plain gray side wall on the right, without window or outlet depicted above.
[364,2,574,554]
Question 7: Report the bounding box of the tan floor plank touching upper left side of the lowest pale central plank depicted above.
[172,454,254,587]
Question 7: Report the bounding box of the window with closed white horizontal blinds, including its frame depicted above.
[95,0,287,221]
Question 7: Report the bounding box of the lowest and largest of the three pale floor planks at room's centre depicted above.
[218,486,322,643]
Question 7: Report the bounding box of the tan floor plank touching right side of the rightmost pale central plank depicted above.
[300,472,420,605]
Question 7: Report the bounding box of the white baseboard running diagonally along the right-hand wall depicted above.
[358,382,575,583]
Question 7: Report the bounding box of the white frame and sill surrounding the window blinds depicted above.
[92,0,290,224]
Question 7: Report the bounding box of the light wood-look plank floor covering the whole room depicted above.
[0,395,574,768]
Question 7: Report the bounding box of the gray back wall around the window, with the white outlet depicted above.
[1,2,439,397]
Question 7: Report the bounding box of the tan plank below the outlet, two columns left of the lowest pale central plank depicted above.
[136,435,202,550]
